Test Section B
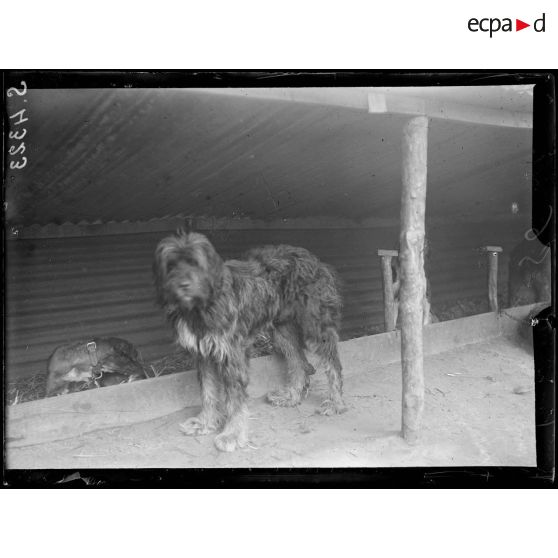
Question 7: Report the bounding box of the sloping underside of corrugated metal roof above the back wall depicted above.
[7,88,532,225]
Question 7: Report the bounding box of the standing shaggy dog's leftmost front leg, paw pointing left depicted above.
[179,359,224,436]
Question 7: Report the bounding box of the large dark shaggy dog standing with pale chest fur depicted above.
[154,231,346,451]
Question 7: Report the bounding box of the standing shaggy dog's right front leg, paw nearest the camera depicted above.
[215,351,248,451]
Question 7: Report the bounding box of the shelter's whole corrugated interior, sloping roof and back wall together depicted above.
[6,86,532,379]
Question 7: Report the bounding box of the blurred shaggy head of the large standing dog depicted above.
[154,230,223,312]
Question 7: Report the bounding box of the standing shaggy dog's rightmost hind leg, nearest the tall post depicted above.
[316,327,347,415]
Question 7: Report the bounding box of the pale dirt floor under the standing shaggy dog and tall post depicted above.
[7,338,536,469]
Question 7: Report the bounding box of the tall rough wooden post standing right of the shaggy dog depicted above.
[399,116,428,444]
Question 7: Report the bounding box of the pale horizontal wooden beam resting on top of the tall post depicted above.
[368,92,533,128]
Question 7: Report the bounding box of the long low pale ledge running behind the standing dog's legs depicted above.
[6,305,537,447]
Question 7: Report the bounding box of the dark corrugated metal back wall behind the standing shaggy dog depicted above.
[6,222,525,379]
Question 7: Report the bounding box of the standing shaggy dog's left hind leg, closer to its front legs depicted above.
[267,324,316,407]
